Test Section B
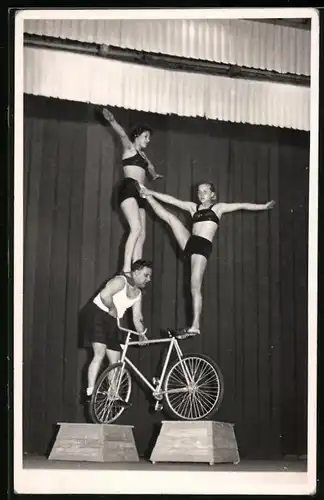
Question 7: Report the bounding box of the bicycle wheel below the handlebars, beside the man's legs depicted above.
[89,363,132,424]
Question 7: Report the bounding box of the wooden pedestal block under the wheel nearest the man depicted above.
[48,423,139,462]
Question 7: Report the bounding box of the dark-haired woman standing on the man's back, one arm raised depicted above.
[103,108,162,275]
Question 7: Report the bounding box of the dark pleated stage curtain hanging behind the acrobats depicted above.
[23,96,309,458]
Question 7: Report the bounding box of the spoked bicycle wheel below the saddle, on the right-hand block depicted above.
[164,354,224,420]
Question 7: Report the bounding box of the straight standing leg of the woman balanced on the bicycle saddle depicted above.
[187,254,207,333]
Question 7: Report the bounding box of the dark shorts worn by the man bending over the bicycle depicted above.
[82,302,123,351]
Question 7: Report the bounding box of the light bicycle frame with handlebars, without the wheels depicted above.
[117,319,191,395]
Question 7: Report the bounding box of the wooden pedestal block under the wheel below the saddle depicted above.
[150,420,240,465]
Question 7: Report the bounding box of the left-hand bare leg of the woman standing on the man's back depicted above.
[120,198,142,273]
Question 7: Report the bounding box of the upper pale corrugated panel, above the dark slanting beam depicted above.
[24,19,310,75]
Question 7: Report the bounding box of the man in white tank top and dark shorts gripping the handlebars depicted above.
[84,260,152,400]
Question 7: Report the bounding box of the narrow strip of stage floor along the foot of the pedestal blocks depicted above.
[23,455,307,473]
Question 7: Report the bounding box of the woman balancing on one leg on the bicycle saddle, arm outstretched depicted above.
[140,182,275,336]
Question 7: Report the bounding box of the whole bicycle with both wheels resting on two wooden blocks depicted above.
[89,319,224,424]
